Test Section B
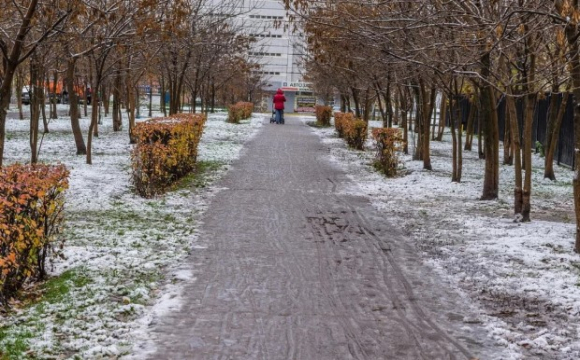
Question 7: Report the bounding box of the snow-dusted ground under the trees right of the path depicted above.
[303,118,580,360]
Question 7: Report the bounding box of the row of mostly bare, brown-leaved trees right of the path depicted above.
[285,0,580,252]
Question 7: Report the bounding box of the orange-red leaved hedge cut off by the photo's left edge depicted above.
[0,164,69,305]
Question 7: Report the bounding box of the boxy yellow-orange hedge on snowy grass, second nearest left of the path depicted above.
[131,114,206,197]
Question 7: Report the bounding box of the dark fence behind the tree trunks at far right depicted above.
[460,94,574,168]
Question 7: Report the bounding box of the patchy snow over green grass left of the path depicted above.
[0,106,263,359]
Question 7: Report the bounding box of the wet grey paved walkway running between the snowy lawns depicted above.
[151,116,502,360]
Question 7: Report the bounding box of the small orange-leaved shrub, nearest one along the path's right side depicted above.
[372,128,404,177]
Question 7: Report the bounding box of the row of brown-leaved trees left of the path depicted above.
[0,0,259,166]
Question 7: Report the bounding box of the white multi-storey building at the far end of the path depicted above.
[242,0,316,112]
